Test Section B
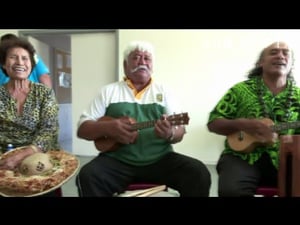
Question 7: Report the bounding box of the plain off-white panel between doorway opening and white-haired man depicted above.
[71,32,117,155]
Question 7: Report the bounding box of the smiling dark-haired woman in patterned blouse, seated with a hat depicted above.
[0,39,59,196]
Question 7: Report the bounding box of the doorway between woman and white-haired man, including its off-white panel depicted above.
[19,30,118,156]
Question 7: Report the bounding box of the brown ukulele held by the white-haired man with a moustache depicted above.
[94,113,190,152]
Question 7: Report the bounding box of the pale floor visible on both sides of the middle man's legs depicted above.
[62,156,217,197]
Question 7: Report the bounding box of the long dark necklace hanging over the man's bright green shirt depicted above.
[256,78,294,122]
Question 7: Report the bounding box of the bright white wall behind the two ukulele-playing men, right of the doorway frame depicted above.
[119,30,300,163]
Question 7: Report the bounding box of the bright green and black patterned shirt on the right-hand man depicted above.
[208,77,300,168]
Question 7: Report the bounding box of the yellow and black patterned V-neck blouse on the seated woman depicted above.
[0,83,59,152]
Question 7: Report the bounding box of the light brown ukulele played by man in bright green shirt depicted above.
[227,118,300,153]
